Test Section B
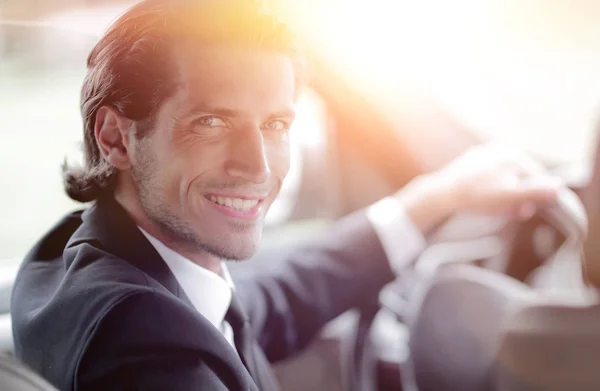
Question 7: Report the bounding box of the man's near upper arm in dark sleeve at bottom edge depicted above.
[74,291,256,391]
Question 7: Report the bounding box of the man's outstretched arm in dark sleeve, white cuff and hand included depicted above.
[238,145,563,361]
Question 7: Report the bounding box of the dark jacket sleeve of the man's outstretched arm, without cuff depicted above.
[236,211,394,361]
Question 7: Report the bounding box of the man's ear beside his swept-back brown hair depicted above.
[94,106,133,170]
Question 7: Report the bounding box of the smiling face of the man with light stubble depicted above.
[131,46,296,259]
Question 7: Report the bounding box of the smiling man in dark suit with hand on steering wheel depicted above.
[12,0,561,390]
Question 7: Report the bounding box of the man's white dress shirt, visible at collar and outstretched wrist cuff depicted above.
[140,197,426,340]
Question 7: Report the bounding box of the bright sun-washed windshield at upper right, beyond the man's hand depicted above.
[280,0,600,172]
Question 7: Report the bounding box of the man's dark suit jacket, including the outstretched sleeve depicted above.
[12,199,393,391]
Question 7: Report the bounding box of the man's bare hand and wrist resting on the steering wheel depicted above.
[398,144,565,234]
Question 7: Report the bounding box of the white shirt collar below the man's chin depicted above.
[138,227,234,330]
